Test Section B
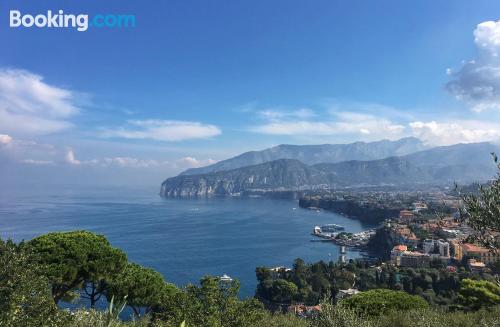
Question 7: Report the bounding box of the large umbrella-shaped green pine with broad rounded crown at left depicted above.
[27,231,127,307]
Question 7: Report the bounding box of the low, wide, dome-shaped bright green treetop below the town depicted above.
[340,289,428,316]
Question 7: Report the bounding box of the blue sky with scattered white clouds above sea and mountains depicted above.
[0,0,500,183]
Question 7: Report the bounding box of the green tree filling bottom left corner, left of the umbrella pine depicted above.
[0,240,69,327]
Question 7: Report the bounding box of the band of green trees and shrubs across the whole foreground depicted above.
[0,232,500,327]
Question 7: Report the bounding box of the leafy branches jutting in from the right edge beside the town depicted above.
[461,154,500,249]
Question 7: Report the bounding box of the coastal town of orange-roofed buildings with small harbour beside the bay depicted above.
[308,189,500,271]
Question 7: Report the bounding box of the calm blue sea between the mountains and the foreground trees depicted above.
[0,187,371,297]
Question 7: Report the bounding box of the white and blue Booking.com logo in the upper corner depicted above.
[10,9,135,32]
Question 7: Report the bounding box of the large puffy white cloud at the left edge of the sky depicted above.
[0,69,79,135]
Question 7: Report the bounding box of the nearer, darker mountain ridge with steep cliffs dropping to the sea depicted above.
[161,143,500,197]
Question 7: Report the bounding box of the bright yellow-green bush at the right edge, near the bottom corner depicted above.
[459,279,500,310]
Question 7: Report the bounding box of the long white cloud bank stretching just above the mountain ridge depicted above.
[250,104,500,145]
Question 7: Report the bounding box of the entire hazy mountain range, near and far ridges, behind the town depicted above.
[161,138,500,197]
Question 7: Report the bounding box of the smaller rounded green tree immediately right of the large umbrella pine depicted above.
[106,263,178,317]
